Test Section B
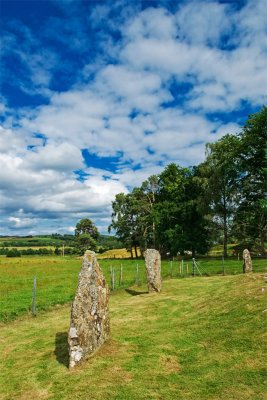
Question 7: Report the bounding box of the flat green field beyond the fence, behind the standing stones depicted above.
[0,256,267,321]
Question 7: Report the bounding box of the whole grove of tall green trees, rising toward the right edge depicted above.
[109,107,267,256]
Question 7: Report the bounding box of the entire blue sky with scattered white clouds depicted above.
[0,0,267,235]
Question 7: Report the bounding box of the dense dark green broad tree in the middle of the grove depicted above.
[156,164,209,256]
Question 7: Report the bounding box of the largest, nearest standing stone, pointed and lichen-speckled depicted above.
[68,250,110,368]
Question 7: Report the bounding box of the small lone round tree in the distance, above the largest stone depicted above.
[75,218,99,254]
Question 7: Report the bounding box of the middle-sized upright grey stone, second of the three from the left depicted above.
[144,249,161,292]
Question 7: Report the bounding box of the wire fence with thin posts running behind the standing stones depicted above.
[0,258,267,322]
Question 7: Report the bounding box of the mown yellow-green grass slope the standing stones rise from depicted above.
[0,274,267,400]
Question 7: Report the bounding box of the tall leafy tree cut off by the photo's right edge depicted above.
[234,107,267,254]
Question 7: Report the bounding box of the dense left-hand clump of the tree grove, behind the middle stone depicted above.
[110,164,209,255]
